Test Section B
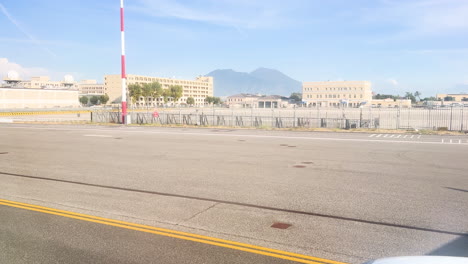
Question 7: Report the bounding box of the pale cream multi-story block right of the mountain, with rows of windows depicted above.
[302,81,372,107]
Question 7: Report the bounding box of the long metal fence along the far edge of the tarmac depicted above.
[92,107,468,131]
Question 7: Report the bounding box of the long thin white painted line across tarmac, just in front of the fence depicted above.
[2,126,468,146]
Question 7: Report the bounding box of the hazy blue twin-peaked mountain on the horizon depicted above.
[206,68,302,96]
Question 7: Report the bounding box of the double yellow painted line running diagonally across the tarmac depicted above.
[0,199,346,264]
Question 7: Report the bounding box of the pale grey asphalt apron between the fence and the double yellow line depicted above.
[0,124,468,263]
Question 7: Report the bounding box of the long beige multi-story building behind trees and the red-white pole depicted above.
[104,74,213,105]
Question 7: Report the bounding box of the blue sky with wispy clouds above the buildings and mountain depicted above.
[0,0,468,97]
